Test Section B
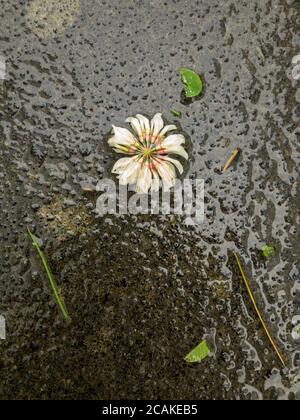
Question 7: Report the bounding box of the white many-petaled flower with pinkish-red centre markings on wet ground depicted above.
[108,114,188,194]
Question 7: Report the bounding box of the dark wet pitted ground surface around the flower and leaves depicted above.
[0,0,300,399]
